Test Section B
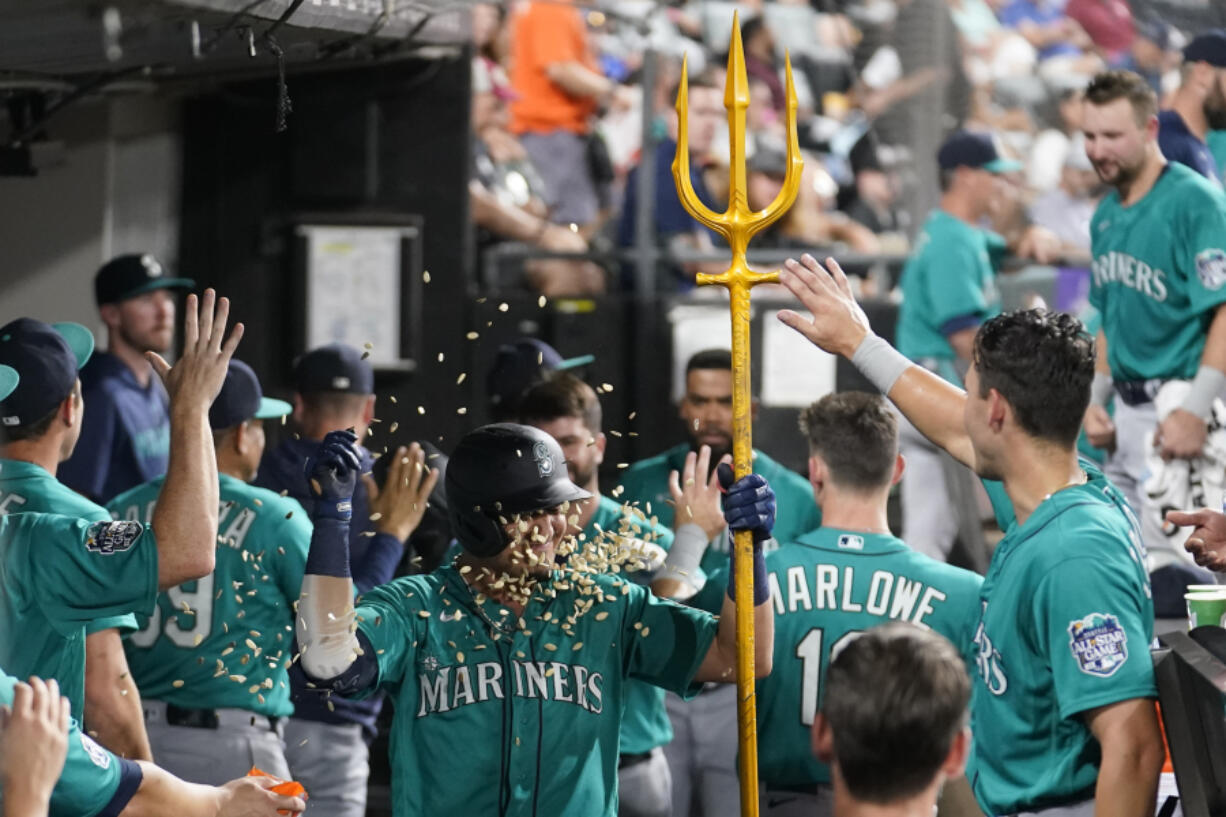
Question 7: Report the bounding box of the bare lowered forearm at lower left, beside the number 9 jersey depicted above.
[83,629,153,761]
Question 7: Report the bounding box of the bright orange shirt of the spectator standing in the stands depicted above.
[511,0,600,134]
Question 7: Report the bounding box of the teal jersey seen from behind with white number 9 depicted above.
[109,474,311,718]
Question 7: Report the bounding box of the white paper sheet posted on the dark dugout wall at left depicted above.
[300,226,403,367]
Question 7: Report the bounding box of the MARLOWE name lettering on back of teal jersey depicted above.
[770,564,945,624]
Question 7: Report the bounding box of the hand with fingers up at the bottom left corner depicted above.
[0,678,69,816]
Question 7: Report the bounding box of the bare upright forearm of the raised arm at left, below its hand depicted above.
[153,404,219,590]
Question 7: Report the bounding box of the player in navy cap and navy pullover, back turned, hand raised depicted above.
[255,343,438,817]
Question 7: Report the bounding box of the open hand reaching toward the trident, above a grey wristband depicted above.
[779,253,872,357]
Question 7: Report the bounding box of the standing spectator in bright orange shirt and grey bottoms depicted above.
[510,0,636,234]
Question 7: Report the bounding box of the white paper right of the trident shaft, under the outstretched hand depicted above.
[761,312,836,407]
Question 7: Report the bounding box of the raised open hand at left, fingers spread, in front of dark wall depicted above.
[146,290,243,409]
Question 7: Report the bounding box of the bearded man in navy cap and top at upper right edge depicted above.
[1157,29,1226,184]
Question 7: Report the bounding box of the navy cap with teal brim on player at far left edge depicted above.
[0,318,93,427]
